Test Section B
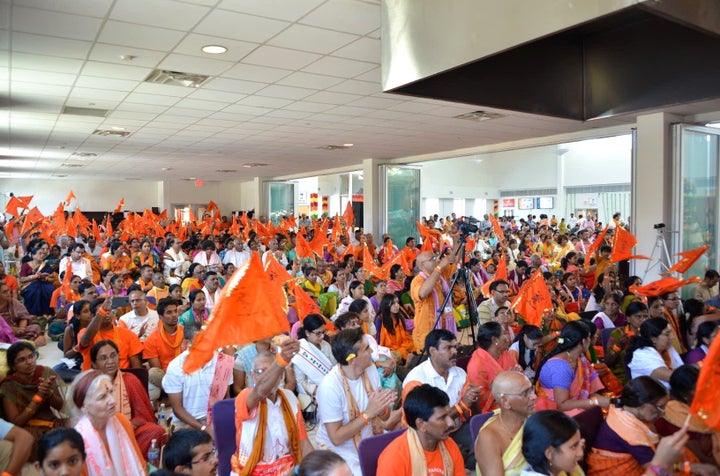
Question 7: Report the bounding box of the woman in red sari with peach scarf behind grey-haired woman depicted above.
[90,340,168,457]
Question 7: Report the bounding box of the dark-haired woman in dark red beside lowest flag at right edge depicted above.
[655,365,720,465]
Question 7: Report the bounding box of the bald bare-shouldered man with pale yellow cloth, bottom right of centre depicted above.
[475,371,537,476]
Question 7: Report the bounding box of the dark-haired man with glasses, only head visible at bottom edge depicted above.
[163,428,217,476]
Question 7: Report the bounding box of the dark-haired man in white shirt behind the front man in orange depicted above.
[402,329,480,470]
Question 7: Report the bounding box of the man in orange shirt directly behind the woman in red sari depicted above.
[76,298,143,371]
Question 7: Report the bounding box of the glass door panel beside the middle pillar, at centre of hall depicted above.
[376,165,420,245]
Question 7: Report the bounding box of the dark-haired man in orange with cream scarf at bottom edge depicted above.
[378,384,465,476]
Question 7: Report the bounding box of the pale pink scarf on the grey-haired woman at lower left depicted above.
[75,414,145,476]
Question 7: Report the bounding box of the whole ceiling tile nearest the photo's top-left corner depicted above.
[12,7,101,40]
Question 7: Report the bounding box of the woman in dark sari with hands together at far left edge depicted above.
[0,341,65,459]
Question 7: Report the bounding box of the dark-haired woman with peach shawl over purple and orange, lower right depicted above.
[587,376,717,476]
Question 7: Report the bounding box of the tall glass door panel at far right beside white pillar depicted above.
[668,124,720,290]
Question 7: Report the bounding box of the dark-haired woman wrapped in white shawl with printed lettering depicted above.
[292,314,337,411]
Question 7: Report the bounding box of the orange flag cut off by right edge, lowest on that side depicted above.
[690,339,720,431]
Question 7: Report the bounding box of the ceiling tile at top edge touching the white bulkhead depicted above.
[300,0,380,35]
